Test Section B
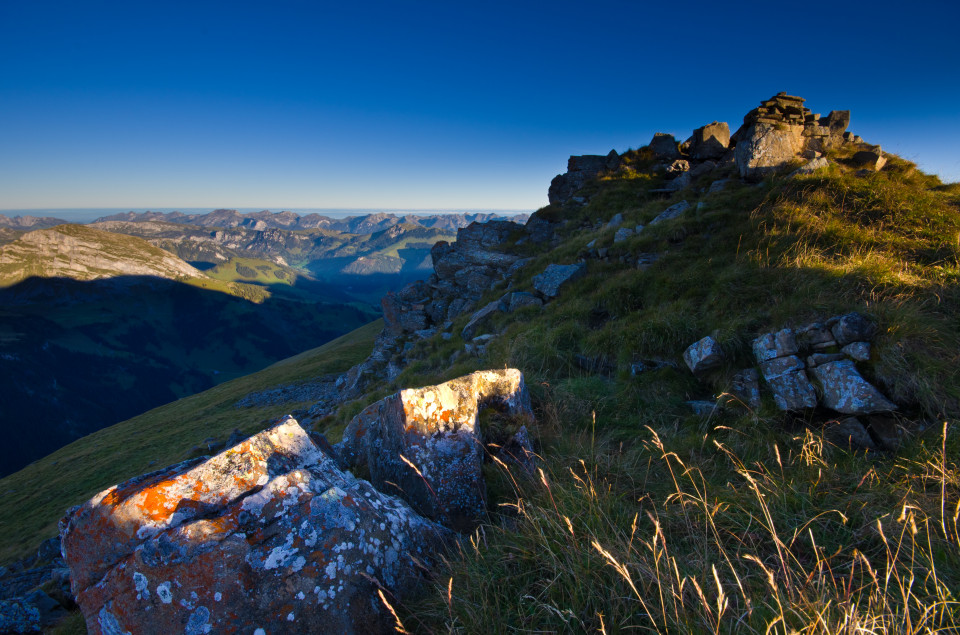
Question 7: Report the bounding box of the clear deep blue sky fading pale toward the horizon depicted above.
[0,0,960,209]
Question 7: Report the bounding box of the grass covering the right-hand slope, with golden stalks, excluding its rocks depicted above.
[362,148,960,633]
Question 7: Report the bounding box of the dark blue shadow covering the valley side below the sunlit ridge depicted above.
[0,276,376,476]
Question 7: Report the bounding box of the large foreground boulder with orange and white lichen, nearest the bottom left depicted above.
[61,418,447,634]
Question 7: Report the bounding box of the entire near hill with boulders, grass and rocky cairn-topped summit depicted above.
[0,93,960,634]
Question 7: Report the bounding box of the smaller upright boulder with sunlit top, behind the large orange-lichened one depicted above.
[337,369,532,531]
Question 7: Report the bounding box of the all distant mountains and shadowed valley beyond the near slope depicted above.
[0,210,524,475]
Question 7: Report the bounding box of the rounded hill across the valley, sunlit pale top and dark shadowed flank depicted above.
[0,225,377,474]
